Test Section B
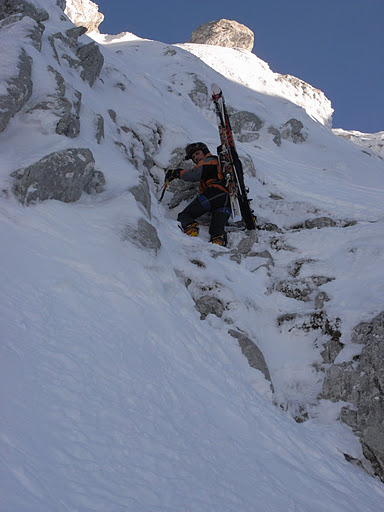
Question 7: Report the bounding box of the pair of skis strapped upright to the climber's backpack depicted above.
[211,84,256,229]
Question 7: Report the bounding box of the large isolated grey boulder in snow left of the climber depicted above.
[12,148,100,205]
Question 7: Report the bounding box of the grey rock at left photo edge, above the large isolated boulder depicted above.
[0,50,32,132]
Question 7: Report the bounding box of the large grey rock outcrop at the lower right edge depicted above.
[322,311,384,482]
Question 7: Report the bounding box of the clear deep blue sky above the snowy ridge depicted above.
[94,0,384,133]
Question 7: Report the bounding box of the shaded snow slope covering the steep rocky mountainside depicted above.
[0,0,384,512]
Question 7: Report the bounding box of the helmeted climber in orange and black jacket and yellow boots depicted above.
[165,142,231,246]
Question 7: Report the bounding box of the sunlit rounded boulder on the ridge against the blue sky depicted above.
[189,19,254,51]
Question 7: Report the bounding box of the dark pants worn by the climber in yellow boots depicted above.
[177,187,231,239]
